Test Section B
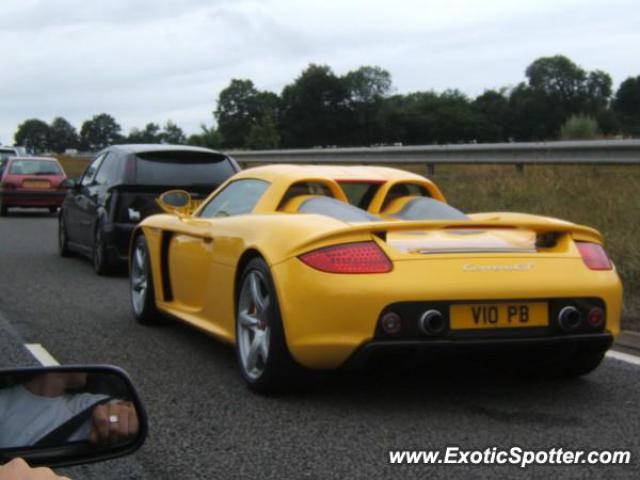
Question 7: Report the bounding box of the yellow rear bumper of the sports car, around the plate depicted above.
[272,255,622,369]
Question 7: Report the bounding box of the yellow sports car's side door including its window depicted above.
[168,179,269,320]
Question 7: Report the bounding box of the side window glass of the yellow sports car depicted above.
[200,179,269,218]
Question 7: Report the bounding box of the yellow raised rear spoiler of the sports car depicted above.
[292,217,603,250]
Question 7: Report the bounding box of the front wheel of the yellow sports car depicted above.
[129,235,161,325]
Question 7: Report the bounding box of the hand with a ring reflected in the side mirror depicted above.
[89,402,139,444]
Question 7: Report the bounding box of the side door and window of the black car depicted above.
[64,152,106,247]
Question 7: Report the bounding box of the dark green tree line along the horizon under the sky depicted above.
[10,55,640,152]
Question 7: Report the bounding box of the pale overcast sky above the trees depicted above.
[0,0,640,144]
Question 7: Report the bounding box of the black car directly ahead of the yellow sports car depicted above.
[58,145,240,275]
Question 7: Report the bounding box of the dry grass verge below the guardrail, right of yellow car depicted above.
[408,165,640,327]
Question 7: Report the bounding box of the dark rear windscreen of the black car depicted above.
[136,151,236,187]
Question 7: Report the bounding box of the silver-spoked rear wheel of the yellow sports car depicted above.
[236,258,303,393]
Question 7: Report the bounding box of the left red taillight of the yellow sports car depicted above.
[299,242,393,273]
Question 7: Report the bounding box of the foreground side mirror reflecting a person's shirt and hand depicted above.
[0,365,147,467]
